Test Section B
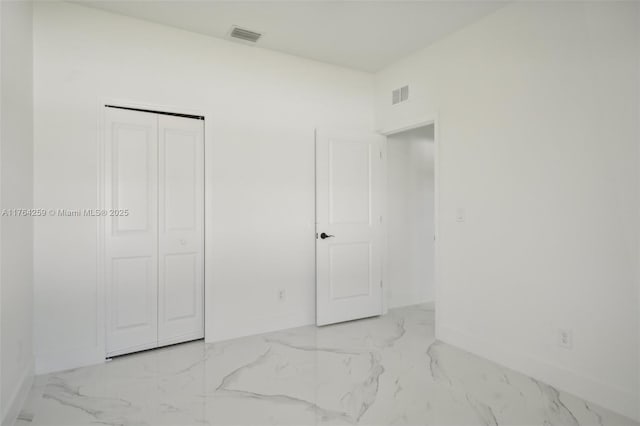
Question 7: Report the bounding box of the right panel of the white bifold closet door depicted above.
[158,115,204,346]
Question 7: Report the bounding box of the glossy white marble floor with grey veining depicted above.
[17,305,637,426]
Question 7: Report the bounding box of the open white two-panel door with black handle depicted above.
[316,131,384,325]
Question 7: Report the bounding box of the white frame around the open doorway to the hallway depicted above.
[378,113,442,332]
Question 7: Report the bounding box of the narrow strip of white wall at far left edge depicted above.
[0,1,33,425]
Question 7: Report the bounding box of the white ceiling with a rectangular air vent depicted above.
[78,0,505,72]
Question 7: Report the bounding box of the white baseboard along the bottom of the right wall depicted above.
[436,324,640,421]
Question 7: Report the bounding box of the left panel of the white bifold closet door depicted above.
[105,108,158,356]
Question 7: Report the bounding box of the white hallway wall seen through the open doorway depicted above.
[386,125,435,308]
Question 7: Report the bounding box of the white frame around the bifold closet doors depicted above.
[97,98,214,363]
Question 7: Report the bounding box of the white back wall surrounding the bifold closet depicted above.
[34,2,373,372]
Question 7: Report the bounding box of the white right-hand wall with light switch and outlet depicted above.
[376,2,640,417]
